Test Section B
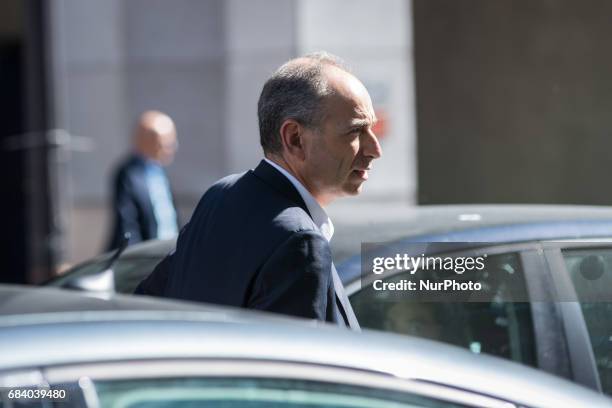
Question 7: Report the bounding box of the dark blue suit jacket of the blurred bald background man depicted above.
[107,155,178,250]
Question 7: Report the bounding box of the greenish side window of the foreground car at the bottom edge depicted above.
[94,378,465,408]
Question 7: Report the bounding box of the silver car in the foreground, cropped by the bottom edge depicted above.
[0,286,612,408]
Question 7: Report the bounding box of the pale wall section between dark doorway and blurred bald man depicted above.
[49,0,131,262]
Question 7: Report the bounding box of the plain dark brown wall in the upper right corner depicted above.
[414,0,612,204]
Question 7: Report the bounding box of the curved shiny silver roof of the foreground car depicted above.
[0,287,610,406]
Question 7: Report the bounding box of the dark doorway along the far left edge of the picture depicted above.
[0,0,52,283]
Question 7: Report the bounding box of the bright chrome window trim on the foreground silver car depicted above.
[43,359,516,408]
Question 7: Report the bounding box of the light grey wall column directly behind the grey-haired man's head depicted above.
[224,0,299,173]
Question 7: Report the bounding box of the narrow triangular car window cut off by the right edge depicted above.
[563,249,612,394]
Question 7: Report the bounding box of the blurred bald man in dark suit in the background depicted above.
[108,111,178,250]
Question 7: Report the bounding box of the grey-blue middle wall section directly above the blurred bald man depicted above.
[123,0,227,194]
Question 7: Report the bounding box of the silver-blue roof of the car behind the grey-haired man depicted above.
[330,203,612,259]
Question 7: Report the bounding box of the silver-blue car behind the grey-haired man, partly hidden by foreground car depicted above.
[49,205,612,394]
